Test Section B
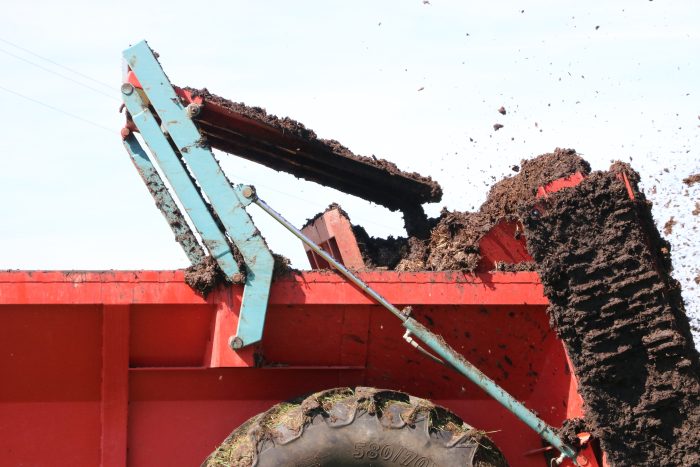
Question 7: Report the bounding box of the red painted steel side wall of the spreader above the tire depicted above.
[0,271,600,467]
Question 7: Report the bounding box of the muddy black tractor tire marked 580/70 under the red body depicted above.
[202,387,508,467]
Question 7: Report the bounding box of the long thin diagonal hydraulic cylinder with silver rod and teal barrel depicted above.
[253,199,578,465]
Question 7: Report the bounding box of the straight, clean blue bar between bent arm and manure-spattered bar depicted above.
[122,88,240,277]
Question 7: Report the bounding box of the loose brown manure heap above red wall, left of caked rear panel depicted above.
[355,148,590,272]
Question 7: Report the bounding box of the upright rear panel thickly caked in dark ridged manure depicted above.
[523,164,700,466]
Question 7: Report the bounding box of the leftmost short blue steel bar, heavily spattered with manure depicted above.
[124,134,205,265]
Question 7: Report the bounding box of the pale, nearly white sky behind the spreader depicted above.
[0,0,700,334]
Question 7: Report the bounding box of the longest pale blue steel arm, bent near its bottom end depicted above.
[123,41,274,348]
